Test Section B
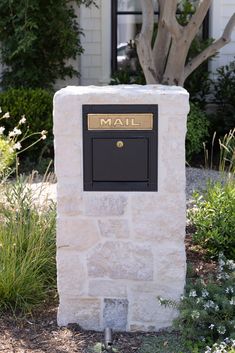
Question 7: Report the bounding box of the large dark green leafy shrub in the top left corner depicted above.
[0,0,96,88]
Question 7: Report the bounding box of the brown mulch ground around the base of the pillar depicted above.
[0,228,215,353]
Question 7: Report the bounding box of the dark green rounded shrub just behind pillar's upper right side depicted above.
[186,103,209,162]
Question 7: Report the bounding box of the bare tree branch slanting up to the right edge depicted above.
[184,13,235,79]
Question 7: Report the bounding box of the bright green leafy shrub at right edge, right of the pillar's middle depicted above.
[189,180,235,260]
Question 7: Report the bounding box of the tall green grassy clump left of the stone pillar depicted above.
[0,180,56,313]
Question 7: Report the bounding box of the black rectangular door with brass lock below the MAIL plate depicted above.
[92,138,148,182]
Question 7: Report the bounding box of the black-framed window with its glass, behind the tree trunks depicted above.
[111,0,209,73]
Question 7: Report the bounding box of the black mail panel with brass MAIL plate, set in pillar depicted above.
[83,105,158,191]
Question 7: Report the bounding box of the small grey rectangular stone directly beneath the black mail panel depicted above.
[84,192,127,217]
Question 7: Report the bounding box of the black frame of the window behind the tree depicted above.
[111,0,209,75]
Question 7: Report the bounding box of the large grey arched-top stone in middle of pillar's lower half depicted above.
[87,241,153,280]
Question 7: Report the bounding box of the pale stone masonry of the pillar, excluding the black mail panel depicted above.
[53,85,189,331]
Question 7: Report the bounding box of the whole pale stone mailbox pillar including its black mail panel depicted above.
[54,85,189,331]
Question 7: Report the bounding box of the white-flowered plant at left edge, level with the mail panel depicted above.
[0,108,47,178]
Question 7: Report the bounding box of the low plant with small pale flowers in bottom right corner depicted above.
[159,254,235,352]
